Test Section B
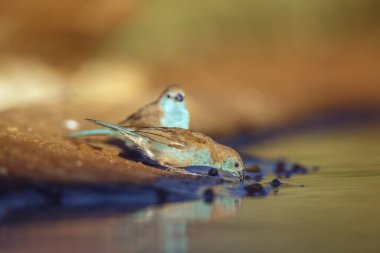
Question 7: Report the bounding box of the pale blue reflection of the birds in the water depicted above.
[133,197,242,253]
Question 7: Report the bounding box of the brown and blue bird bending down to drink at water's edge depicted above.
[86,119,244,180]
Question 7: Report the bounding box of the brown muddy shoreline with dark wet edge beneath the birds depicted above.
[0,104,380,223]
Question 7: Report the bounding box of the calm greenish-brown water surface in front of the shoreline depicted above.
[0,126,380,253]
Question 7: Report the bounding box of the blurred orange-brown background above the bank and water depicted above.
[0,0,380,133]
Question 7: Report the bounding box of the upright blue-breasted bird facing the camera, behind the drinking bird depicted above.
[67,84,190,137]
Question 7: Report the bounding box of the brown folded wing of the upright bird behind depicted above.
[119,102,163,127]
